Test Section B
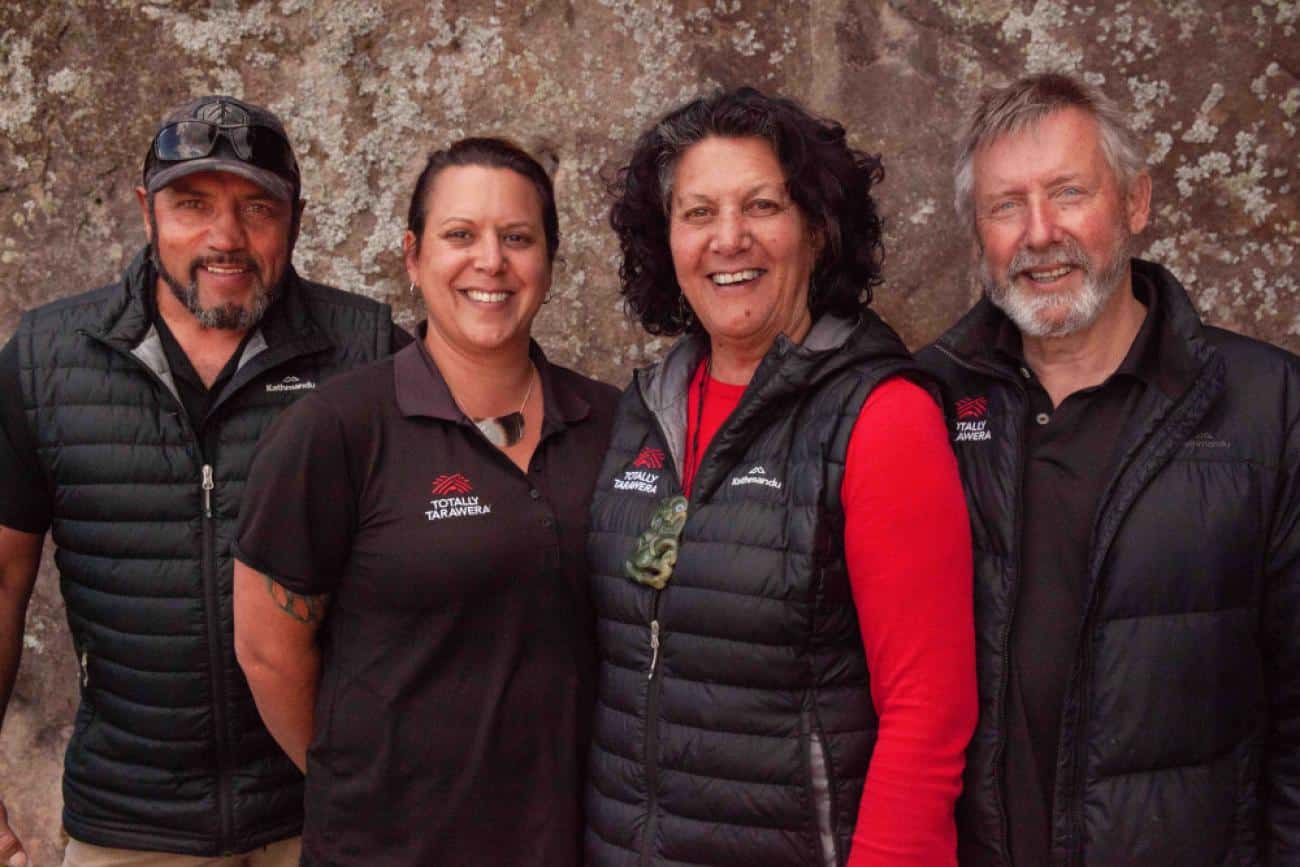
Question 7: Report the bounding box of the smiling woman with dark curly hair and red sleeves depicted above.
[586,88,975,867]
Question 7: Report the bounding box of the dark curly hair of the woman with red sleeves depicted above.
[610,87,884,335]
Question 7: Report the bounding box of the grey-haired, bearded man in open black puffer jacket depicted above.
[919,74,1300,867]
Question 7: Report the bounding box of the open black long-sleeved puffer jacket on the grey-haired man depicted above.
[919,260,1300,867]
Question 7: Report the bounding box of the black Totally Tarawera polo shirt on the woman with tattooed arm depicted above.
[237,341,618,867]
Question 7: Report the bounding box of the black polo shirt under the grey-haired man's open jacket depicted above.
[997,274,1164,867]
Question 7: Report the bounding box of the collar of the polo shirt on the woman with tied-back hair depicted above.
[393,321,592,437]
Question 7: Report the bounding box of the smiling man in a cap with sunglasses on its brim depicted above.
[0,96,408,867]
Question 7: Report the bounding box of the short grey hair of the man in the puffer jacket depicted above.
[953,73,1145,229]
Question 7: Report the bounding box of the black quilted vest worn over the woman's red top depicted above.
[586,313,913,867]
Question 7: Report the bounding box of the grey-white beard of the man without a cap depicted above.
[979,226,1132,338]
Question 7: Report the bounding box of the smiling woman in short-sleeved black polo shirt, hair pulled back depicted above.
[235,139,616,867]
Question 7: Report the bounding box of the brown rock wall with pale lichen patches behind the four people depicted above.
[0,0,1300,864]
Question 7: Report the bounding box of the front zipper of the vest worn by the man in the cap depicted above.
[78,329,243,855]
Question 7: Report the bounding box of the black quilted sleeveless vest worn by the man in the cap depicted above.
[14,249,394,857]
